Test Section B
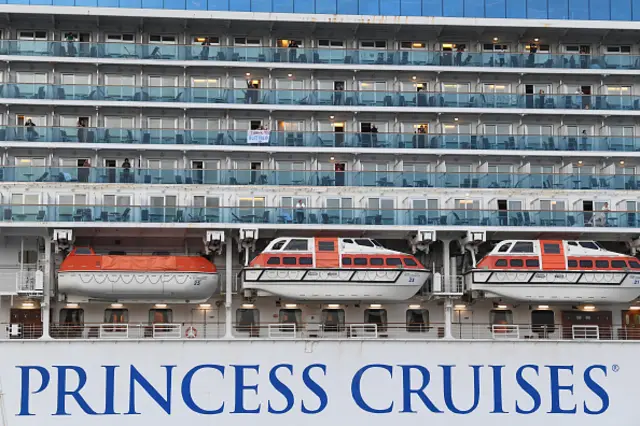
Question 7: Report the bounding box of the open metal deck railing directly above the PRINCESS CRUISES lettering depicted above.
[5,322,640,342]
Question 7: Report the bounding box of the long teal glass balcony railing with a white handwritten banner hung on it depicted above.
[5,126,640,152]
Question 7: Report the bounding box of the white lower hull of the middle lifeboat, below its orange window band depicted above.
[243,268,430,301]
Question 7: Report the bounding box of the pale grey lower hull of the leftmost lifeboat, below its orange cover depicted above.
[58,271,220,303]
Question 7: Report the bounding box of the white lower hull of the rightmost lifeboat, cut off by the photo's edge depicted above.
[465,270,640,303]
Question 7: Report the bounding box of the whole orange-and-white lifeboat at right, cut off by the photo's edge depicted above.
[465,240,640,303]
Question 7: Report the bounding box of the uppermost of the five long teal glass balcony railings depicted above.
[0,40,640,72]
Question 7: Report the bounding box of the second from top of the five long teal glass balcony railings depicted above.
[0,83,640,111]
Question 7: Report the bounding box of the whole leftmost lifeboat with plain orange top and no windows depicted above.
[58,247,219,303]
